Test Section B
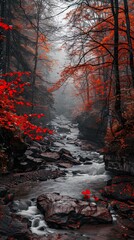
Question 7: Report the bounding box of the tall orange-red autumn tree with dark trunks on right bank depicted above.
[49,0,134,147]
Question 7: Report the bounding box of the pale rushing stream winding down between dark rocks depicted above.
[15,116,119,240]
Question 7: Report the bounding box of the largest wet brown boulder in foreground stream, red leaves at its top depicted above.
[37,193,112,229]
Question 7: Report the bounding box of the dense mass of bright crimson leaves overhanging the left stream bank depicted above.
[0,72,52,140]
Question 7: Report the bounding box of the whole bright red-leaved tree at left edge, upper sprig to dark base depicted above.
[0,4,52,172]
